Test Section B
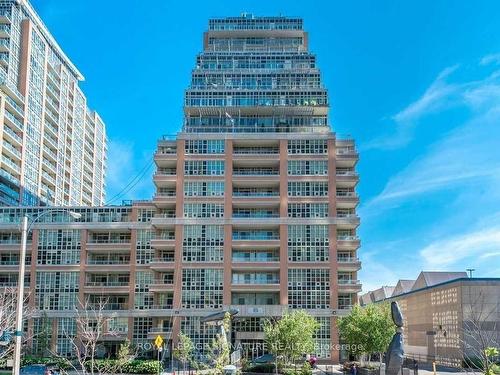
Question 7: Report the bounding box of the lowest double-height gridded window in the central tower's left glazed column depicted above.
[182,268,223,309]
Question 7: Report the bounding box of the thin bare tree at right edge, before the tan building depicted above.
[460,287,500,375]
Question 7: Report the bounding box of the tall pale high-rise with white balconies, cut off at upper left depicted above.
[0,0,106,206]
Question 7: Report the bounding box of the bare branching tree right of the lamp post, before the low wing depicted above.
[58,298,136,375]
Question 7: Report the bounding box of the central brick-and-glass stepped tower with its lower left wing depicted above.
[0,16,361,362]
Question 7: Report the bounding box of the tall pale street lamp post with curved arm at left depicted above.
[13,208,82,375]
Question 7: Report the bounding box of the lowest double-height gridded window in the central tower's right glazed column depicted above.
[288,268,330,309]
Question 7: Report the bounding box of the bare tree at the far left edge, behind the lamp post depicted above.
[0,287,32,359]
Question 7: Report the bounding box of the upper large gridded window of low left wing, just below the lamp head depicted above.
[37,229,81,265]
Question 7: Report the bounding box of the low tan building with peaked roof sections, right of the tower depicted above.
[361,272,500,367]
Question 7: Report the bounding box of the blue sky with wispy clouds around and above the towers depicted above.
[33,0,500,290]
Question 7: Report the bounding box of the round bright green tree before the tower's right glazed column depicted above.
[264,310,319,372]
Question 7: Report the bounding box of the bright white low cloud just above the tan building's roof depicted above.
[420,226,500,269]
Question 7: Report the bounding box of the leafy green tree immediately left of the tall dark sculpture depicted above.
[338,303,395,366]
